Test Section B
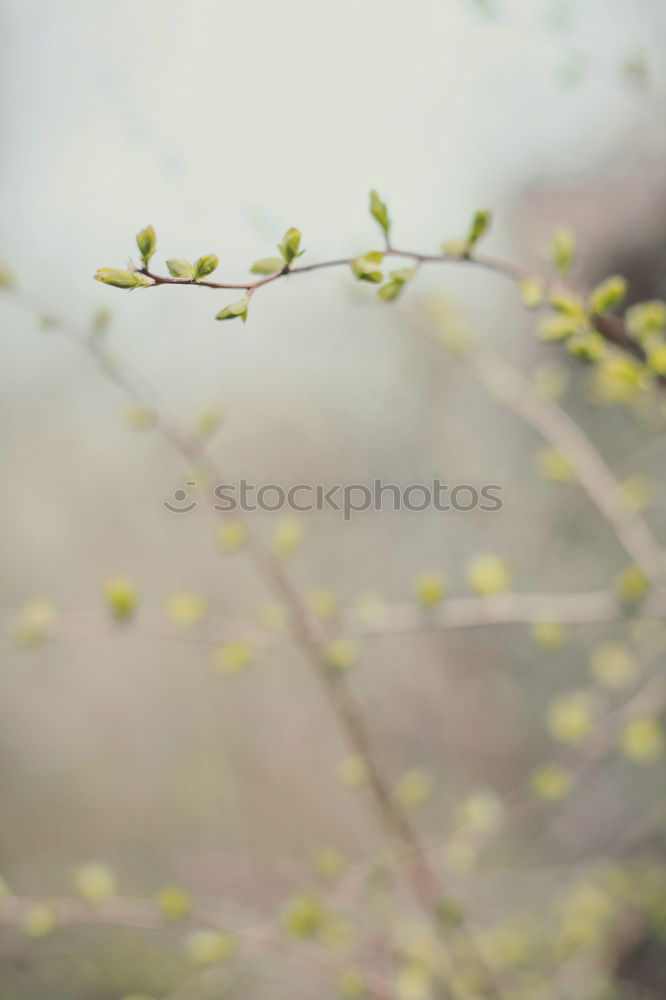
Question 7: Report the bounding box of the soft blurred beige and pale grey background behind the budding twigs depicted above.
[0,0,666,1000]
